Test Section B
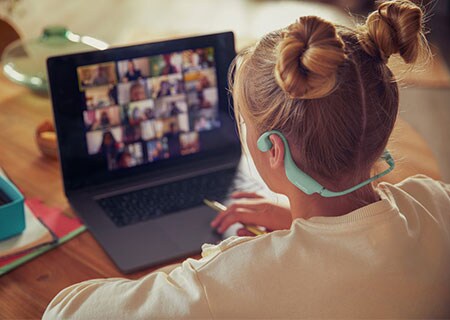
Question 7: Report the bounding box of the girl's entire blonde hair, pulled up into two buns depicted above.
[229,0,429,195]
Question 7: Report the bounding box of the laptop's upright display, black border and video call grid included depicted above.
[47,32,240,191]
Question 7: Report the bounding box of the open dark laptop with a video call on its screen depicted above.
[47,32,258,273]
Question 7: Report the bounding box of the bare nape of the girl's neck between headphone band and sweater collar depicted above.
[288,185,380,220]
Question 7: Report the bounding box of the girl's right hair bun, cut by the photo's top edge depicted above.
[358,0,427,63]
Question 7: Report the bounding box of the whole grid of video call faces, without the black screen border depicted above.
[77,47,220,170]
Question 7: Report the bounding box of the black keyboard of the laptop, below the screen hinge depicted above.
[97,168,260,227]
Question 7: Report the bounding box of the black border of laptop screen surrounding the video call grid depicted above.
[47,32,241,194]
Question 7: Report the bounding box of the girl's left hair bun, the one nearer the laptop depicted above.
[275,16,345,99]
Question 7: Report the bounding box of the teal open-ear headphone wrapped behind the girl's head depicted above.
[257,130,395,198]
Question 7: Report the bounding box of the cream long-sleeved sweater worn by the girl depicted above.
[44,176,450,319]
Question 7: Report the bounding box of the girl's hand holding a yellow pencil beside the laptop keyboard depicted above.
[211,192,292,236]
